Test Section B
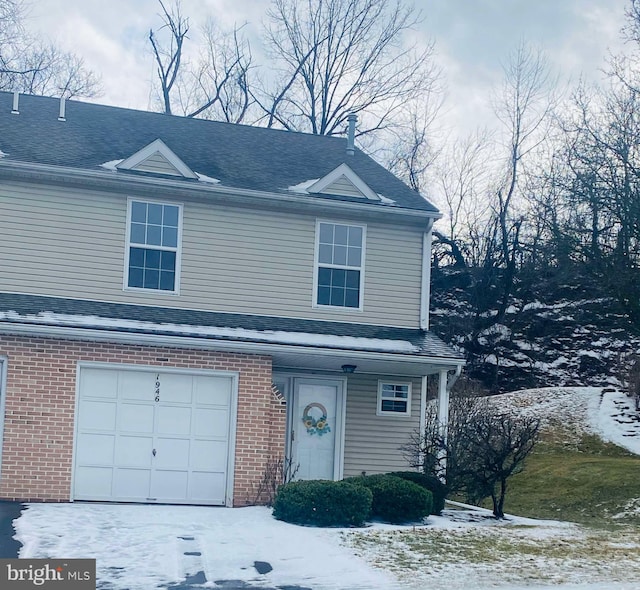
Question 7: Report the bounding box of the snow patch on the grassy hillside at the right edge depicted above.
[491,387,640,455]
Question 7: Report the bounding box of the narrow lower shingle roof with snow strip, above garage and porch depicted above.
[0,293,462,360]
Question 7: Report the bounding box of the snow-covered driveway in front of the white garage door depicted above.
[15,503,397,590]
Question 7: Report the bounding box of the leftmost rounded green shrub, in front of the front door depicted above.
[273,480,372,526]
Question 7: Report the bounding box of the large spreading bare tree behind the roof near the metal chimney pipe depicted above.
[255,0,435,136]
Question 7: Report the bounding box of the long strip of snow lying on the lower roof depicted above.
[0,311,420,353]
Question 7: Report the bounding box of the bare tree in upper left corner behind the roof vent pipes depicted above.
[0,0,101,98]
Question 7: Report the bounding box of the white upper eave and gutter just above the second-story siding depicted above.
[0,158,442,226]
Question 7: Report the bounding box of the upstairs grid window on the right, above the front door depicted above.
[314,221,366,309]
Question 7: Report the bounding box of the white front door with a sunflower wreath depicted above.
[291,379,343,480]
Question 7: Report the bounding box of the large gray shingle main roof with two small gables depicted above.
[0,92,437,212]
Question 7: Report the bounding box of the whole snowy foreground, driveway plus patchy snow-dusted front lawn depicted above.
[16,503,640,590]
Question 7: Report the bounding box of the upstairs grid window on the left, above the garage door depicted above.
[125,200,182,293]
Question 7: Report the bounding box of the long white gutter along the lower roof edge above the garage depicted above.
[0,322,461,370]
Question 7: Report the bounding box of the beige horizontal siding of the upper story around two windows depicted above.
[0,184,422,327]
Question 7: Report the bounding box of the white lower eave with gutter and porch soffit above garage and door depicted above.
[0,321,464,377]
